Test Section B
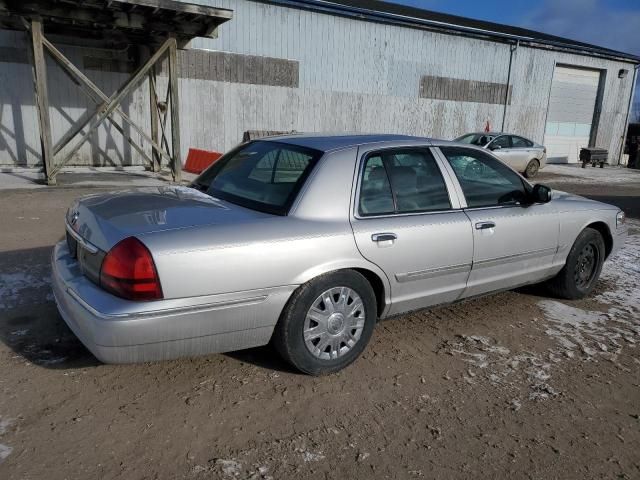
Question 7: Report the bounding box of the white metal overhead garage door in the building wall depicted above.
[544,67,600,163]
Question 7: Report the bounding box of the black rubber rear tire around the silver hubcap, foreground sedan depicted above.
[272,270,377,375]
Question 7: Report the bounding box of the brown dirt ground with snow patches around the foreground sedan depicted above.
[0,167,640,480]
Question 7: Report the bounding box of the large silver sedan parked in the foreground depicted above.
[52,135,626,375]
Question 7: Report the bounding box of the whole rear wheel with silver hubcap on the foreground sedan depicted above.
[272,270,377,375]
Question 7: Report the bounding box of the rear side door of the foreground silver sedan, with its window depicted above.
[351,147,473,314]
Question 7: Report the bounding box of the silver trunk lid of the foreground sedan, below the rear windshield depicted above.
[67,186,270,252]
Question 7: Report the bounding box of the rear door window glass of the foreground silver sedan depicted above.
[359,149,451,216]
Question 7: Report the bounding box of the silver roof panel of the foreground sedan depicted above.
[258,133,432,152]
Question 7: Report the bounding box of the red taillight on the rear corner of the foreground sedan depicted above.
[100,237,162,300]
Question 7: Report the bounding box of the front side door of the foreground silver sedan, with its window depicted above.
[440,147,559,297]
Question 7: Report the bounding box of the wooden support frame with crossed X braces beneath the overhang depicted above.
[23,19,182,185]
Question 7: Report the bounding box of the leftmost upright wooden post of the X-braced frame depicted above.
[31,19,56,185]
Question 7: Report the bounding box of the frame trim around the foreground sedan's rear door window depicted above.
[353,145,462,220]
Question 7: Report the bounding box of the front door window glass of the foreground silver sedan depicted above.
[440,147,527,208]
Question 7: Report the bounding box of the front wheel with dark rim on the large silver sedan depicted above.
[547,228,605,300]
